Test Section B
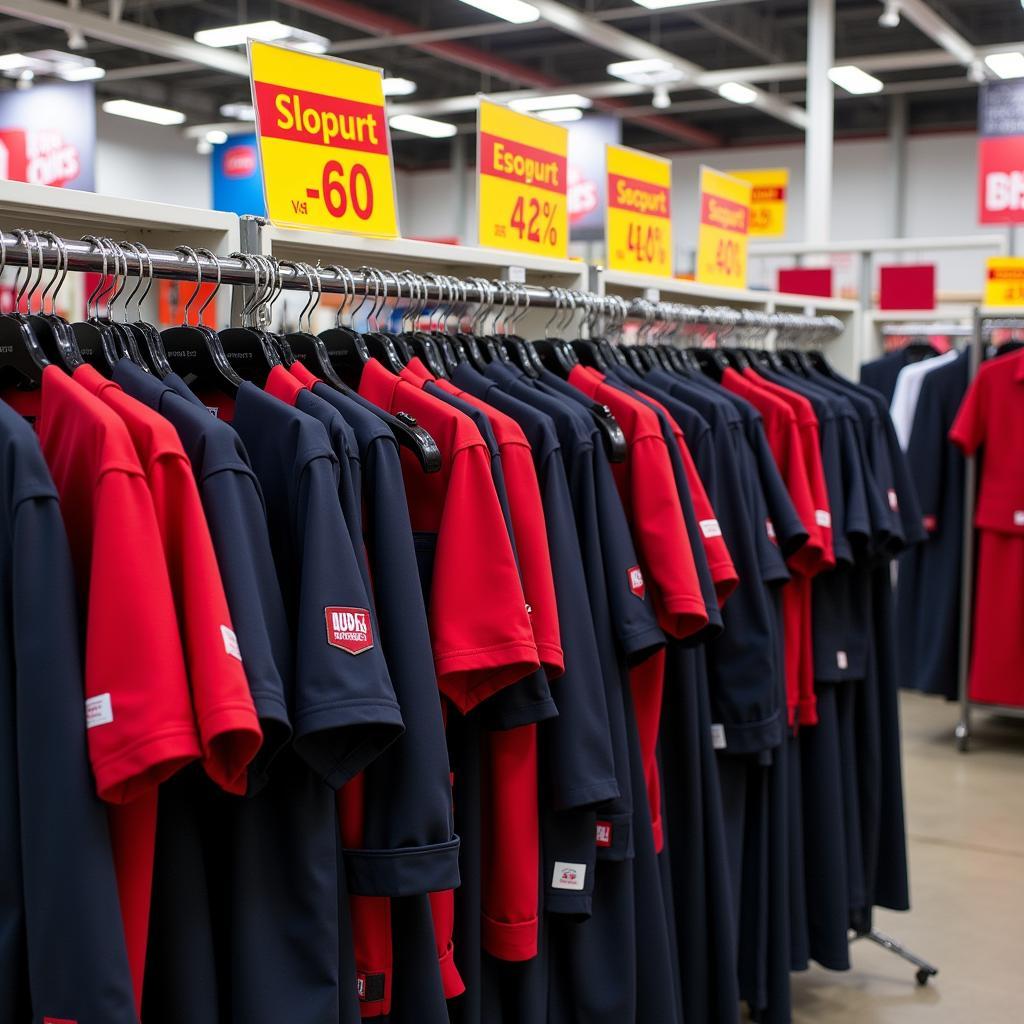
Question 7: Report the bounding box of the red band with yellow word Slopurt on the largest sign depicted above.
[255,82,387,154]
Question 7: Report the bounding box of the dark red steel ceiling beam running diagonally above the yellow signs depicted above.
[284,0,721,146]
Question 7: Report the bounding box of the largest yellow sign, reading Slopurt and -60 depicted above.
[249,41,398,239]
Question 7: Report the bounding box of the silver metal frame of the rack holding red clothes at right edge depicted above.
[953,309,1024,754]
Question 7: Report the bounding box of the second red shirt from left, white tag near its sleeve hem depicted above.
[75,366,263,796]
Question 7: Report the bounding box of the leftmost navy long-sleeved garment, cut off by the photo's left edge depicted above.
[0,402,136,1024]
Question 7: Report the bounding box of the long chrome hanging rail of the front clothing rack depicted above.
[0,230,843,338]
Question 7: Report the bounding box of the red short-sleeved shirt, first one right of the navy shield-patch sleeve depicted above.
[359,359,540,714]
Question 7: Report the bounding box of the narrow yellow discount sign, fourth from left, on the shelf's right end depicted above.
[696,167,752,288]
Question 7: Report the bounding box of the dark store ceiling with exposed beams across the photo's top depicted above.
[0,0,1024,167]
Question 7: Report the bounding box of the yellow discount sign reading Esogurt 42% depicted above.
[476,98,569,259]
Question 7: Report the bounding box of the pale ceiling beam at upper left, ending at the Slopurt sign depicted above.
[0,0,249,77]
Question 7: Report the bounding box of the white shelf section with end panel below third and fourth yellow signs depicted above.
[591,267,860,377]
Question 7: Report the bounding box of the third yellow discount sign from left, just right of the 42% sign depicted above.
[605,145,672,278]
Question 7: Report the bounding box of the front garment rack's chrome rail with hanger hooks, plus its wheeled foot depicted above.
[0,229,937,984]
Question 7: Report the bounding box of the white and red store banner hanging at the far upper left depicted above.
[0,82,96,191]
